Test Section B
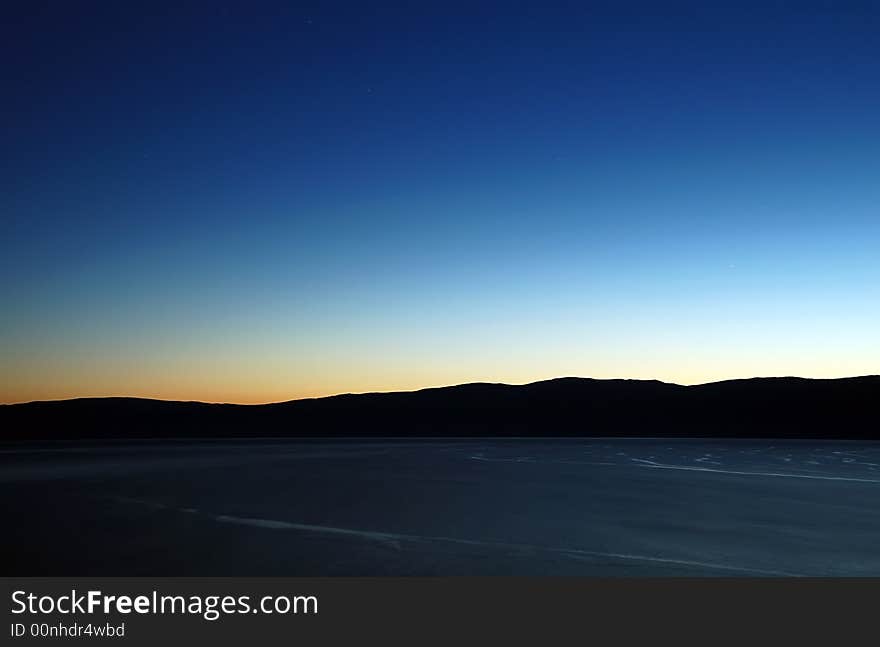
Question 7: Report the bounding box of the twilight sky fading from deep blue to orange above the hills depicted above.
[0,0,880,403]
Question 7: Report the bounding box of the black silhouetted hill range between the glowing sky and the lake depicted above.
[0,376,880,440]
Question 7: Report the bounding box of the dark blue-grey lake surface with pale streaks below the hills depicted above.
[0,439,880,576]
